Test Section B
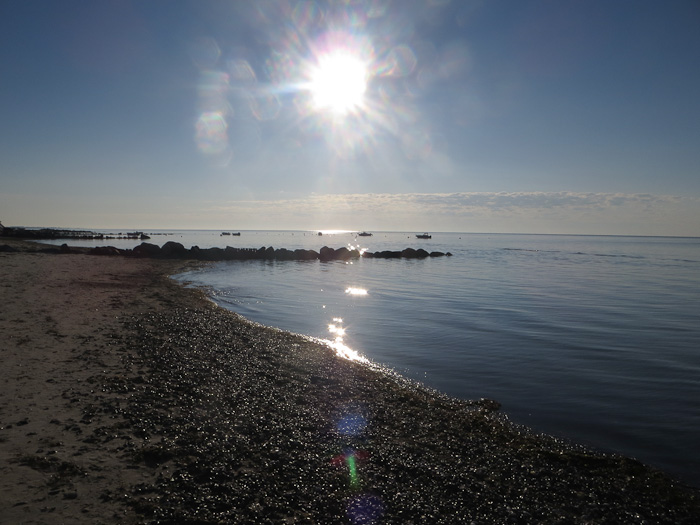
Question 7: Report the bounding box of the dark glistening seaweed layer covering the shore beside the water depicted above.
[79,307,700,524]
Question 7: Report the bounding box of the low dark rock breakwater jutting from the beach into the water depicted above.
[89,241,452,261]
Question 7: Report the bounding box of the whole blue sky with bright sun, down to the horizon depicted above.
[0,0,700,236]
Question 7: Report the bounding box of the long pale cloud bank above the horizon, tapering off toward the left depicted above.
[210,192,700,235]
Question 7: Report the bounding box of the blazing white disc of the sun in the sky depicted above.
[309,51,368,115]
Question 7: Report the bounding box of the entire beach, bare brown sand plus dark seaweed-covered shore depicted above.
[0,238,700,524]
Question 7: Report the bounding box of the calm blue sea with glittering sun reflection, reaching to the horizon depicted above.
[39,230,700,487]
